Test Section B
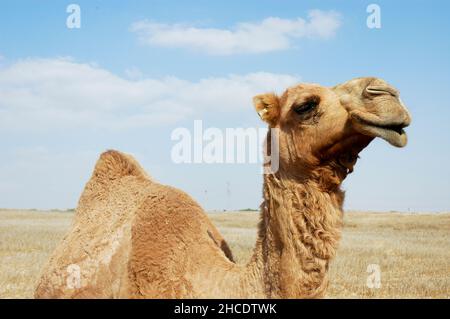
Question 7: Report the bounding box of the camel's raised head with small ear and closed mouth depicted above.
[253,77,411,183]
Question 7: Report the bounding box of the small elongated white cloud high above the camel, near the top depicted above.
[131,10,341,55]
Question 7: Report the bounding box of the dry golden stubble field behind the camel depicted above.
[0,210,450,298]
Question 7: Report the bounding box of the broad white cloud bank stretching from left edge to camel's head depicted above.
[0,58,299,130]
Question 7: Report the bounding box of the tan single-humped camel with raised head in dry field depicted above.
[35,77,411,298]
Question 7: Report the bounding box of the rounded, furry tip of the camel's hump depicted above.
[92,150,150,182]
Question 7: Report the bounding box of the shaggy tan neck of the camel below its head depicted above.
[248,173,343,298]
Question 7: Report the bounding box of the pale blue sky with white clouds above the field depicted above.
[0,1,450,211]
